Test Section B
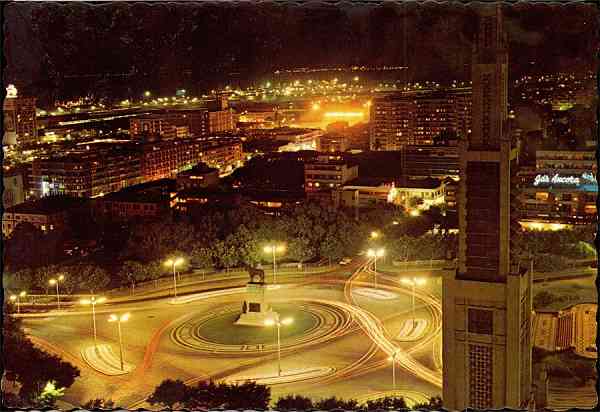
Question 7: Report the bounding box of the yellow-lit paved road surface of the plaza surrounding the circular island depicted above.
[19,262,440,407]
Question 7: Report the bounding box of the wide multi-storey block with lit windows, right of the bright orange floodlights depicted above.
[370,89,471,150]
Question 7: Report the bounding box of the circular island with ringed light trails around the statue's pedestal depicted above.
[170,302,351,356]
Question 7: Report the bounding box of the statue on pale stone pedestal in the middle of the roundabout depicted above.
[235,266,277,326]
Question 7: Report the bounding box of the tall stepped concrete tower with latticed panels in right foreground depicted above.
[443,4,531,410]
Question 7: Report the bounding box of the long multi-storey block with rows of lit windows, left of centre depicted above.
[31,138,244,197]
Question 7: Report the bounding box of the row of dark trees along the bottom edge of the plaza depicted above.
[147,379,442,411]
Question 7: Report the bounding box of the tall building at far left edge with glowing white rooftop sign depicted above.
[2,84,37,145]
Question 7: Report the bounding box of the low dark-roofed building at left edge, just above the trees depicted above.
[2,196,88,237]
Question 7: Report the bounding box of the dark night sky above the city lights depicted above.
[4,2,598,104]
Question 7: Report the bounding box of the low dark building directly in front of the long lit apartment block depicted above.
[94,179,177,221]
